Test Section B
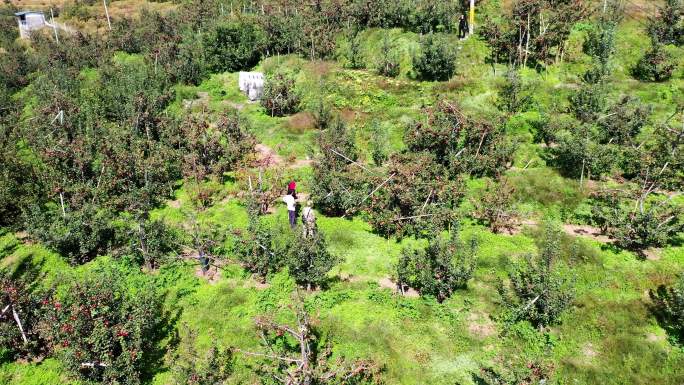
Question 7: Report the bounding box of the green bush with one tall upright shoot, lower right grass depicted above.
[497,222,575,328]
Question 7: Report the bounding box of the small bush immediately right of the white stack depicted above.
[261,72,300,116]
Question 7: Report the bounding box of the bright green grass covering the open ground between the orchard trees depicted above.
[0,16,684,384]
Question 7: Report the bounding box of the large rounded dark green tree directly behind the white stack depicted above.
[203,20,265,72]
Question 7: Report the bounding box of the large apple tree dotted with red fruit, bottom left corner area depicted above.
[40,268,162,384]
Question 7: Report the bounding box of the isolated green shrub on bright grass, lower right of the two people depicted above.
[397,228,477,302]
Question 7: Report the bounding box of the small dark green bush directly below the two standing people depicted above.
[286,231,341,289]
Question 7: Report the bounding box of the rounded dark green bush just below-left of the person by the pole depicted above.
[413,34,456,81]
